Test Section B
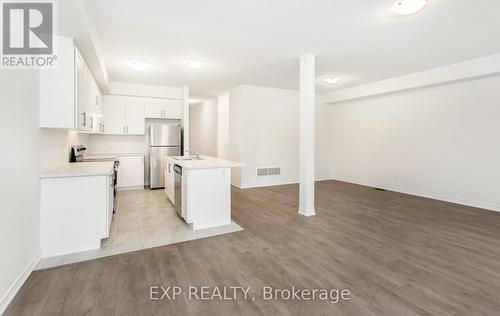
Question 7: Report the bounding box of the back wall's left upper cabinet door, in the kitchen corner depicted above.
[104,95,127,135]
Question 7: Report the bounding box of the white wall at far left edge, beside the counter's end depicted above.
[0,69,40,314]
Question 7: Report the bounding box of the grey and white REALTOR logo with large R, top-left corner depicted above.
[2,0,57,68]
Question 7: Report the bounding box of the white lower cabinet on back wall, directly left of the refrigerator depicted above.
[117,156,145,190]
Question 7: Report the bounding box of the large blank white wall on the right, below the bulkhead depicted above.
[328,76,500,210]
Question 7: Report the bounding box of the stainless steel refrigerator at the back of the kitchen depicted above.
[149,125,182,189]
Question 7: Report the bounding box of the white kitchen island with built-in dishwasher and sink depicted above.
[165,156,243,230]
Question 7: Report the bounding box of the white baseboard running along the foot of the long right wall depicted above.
[331,177,500,212]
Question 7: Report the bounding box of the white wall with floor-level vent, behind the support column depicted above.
[228,85,331,188]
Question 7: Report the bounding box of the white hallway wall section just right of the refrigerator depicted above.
[189,98,218,157]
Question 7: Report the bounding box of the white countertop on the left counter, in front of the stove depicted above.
[40,161,114,179]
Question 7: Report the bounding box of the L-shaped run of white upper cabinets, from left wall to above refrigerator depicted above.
[39,36,182,135]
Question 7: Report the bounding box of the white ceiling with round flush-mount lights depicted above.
[76,0,500,97]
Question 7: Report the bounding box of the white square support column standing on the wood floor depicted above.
[299,54,316,216]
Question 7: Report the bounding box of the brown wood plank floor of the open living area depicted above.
[6,181,500,316]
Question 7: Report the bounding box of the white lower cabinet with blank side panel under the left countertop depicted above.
[40,175,114,258]
